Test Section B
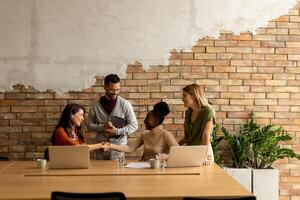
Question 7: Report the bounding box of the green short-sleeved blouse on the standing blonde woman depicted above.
[184,107,215,145]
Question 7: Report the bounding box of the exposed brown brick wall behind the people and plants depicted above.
[0,4,300,200]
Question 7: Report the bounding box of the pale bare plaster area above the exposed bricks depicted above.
[0,0,296,92]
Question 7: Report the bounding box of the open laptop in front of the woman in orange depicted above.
[49,145,90,169]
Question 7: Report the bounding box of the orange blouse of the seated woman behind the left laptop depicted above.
[54,127,84,145]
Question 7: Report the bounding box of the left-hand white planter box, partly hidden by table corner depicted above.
[224,168,252,192]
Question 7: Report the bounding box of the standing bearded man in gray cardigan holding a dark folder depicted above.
[87,74,138,160]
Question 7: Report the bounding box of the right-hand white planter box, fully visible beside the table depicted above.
[252,169,279,200]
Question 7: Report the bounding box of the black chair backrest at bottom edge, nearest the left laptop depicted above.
[51,192,126,200]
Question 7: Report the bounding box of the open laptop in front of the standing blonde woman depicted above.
[167,145,207,167]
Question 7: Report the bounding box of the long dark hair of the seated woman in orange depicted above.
[51,103,85,145]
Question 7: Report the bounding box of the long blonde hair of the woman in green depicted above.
[182,83,210,108]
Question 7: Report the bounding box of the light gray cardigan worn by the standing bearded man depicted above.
[87,96,138,144]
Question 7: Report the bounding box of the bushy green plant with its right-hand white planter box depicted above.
[222,115,300,200]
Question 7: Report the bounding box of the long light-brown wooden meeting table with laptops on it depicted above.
[0,161,251,199]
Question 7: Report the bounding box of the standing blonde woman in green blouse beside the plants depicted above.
[179,84,215,165]
